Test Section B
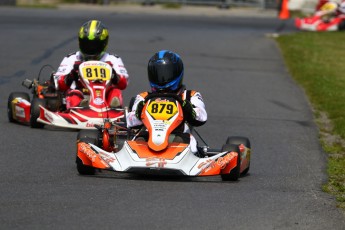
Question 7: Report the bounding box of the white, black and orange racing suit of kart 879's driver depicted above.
[126,86,207,153]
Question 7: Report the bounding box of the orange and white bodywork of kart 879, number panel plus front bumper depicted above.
[77,94,250,176]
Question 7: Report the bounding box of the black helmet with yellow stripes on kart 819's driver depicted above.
[78,20,109,60]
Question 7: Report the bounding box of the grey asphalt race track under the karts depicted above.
[0,5,345,230]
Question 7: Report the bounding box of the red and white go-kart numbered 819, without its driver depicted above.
[7,61,124,129]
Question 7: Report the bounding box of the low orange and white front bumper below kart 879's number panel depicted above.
[78,141,243,176]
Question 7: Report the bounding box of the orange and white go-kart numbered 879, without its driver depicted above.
[76,94,251,181]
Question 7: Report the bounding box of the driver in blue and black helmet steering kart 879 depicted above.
[127,50,207,153]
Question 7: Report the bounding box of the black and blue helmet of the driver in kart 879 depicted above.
[147,50,183,92]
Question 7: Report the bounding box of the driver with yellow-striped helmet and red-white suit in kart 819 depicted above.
[54,20,129,109]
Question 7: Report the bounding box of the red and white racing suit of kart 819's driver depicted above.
[54,51,129,109]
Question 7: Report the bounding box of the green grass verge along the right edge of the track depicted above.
[276,32,345,210]
